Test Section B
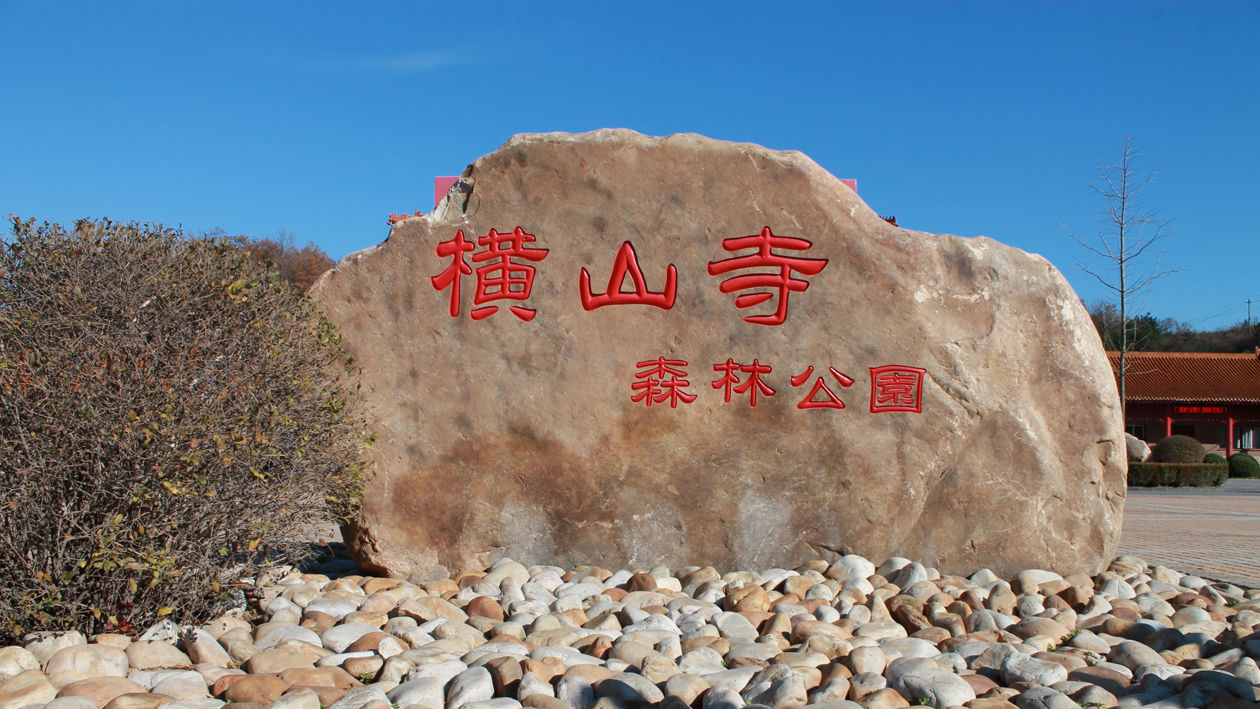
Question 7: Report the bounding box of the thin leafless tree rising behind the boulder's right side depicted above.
[1068,136,1173,413]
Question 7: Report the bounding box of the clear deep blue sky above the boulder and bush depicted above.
[7,0,1260,329]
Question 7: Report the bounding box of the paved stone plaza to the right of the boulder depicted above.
[1119,480,1260,588]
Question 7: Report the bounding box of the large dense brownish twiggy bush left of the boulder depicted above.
[0,219,369,640]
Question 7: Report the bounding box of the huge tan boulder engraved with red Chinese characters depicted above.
[314,130,1125,578]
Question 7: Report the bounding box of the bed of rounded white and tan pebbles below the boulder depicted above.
[0,555,1260,709]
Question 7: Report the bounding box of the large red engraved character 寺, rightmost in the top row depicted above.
[708,227,828,325]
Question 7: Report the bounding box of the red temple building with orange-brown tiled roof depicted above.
[1108,349,1260,456]
